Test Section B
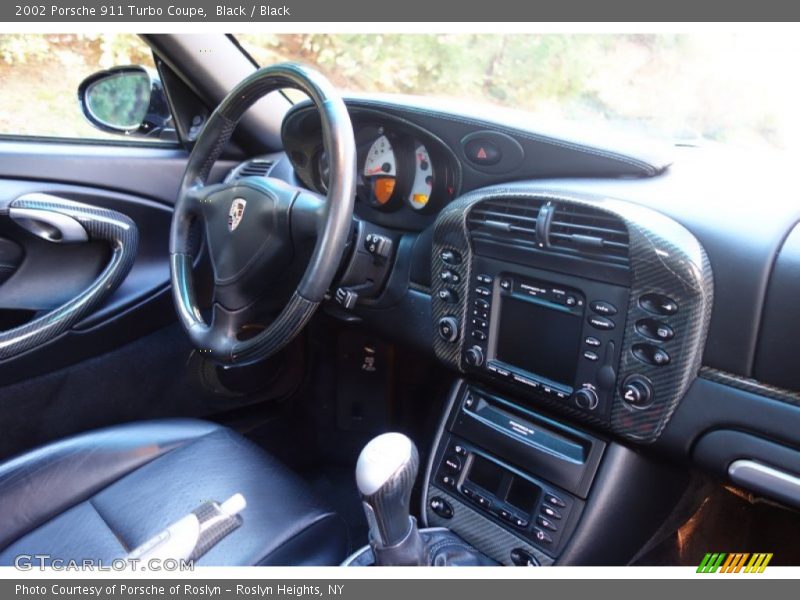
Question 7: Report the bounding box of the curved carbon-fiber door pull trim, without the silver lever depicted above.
[0,194,139,360]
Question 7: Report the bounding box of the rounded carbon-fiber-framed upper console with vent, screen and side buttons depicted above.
[432,189,713,443]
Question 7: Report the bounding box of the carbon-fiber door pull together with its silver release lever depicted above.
[0,193,139,360]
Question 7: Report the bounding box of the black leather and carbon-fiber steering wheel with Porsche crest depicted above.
[170,63,356,365]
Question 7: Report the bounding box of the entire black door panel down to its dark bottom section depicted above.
[0,140,304,460]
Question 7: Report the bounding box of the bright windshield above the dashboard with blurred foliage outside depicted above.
[236,32,800,151]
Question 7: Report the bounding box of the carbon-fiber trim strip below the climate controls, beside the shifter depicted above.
[426,488,553,566]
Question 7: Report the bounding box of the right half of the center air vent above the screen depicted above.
[547,202,629,265]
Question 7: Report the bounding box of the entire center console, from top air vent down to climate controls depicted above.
[422,184,713,565]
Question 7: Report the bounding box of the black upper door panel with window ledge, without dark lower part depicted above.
[0,139,235,384]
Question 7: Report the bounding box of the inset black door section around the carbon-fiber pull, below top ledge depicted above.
[0,178,173,384]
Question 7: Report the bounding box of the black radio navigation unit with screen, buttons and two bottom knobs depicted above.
[463,257,628,419]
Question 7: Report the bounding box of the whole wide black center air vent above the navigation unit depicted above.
[467,198,629,266]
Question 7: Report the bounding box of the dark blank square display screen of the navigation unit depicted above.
[495,296,582,386]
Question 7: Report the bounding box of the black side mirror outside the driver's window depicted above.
[78,66,175,139]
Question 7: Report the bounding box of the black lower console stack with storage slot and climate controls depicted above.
[425,386,606,565]
